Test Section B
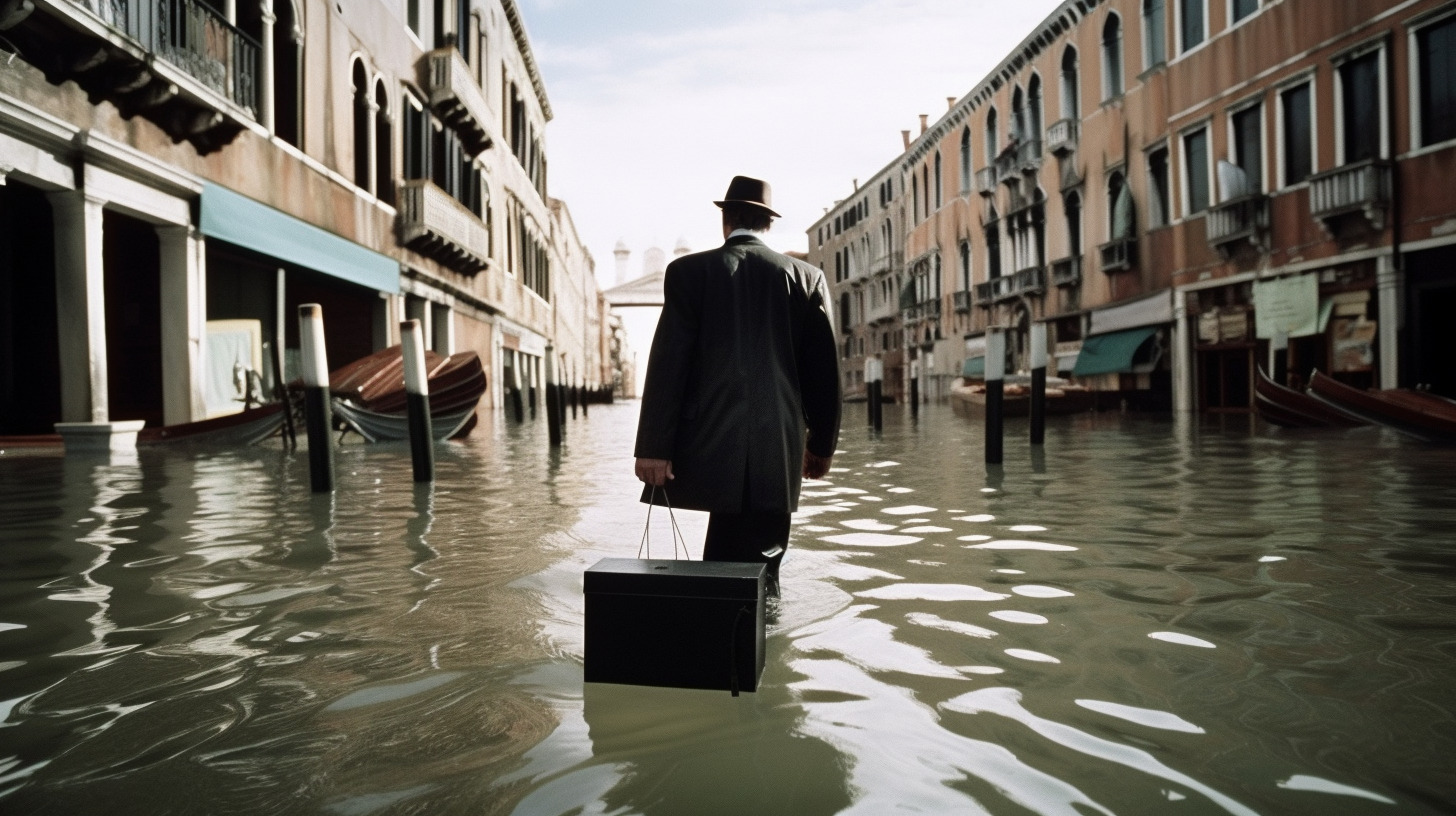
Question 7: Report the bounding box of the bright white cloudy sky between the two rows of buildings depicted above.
[520,0,1060,287]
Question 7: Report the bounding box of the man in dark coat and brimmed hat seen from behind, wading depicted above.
[636,176,840,589]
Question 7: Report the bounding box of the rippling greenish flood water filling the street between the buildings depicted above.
[0,404,1456,816]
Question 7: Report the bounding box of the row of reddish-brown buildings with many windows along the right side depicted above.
[810,0,1456,412]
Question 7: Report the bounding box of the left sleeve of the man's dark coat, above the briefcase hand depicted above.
[635,262,700,459]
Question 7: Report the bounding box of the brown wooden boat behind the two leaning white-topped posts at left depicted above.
[329,345,486,442]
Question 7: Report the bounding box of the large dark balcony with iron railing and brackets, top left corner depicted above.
[0,0,261,154]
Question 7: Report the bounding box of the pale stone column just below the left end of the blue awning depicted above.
[157,226,207,425]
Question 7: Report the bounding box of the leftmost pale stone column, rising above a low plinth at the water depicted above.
[47,191,111,423]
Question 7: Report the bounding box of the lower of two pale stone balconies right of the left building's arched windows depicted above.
[399,179,491,275]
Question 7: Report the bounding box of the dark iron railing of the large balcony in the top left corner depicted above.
[92,0,261,117]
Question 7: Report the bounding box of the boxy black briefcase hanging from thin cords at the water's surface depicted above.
[582,558,764,694]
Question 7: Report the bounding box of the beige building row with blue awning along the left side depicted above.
[0,0,607,434]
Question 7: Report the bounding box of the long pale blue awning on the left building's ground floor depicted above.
[202,184,399,294]
